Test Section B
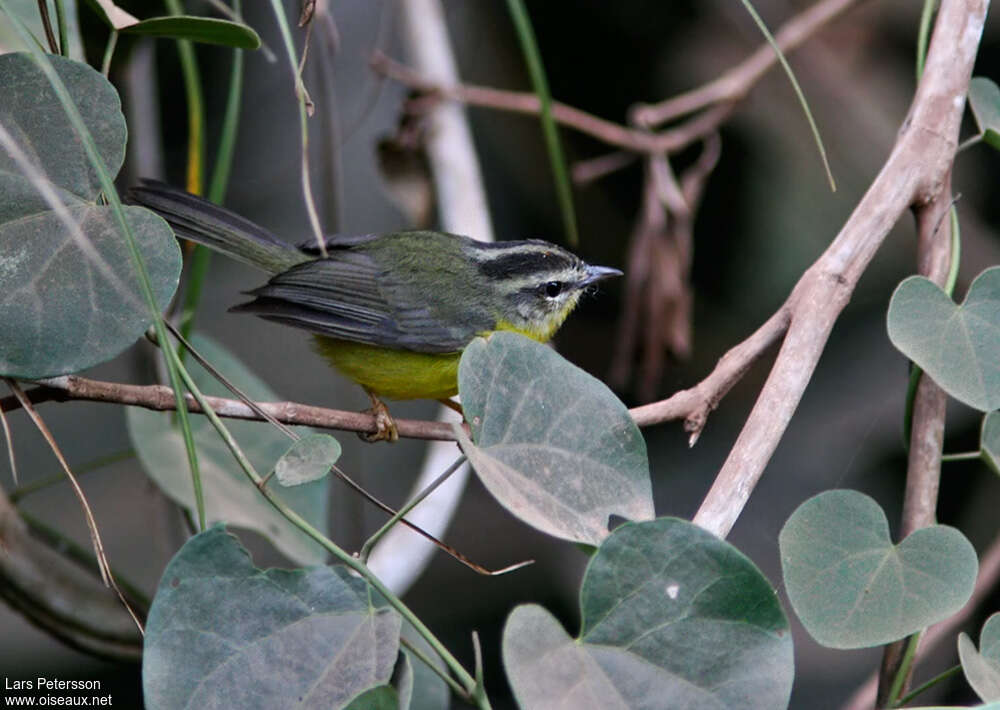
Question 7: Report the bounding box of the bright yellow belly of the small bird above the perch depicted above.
[316,335,462,399]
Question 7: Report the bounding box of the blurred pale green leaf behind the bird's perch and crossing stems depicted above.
[125,335,329,564]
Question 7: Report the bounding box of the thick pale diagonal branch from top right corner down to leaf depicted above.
[694,0,986,537]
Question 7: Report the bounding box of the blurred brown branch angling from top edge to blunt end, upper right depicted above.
[633,0,861,127]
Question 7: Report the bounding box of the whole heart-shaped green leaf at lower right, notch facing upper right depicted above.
[778,490,978,648]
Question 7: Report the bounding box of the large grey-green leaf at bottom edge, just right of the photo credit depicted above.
[142,525,401,710]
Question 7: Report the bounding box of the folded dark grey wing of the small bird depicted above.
[232,256,476,353]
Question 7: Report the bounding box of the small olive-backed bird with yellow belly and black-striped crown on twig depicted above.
[128,180,622,441]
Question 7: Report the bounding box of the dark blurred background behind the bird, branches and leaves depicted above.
[0,0,1000,709]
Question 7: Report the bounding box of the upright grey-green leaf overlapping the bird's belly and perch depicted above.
[458,332,653,545]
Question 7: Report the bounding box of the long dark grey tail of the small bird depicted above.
[127,180,310,273]
